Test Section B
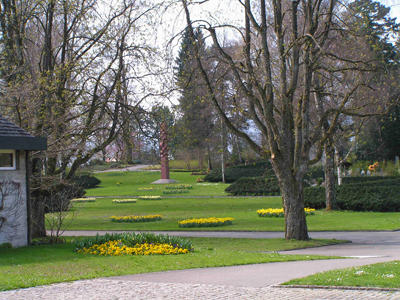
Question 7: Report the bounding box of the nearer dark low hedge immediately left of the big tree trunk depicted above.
[225,177,280,196]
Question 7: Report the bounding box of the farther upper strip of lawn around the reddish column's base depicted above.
[86,171,229,196]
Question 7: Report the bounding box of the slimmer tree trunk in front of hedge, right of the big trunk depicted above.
[324,143,336,210]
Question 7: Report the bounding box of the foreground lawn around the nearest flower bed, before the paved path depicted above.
[0,238,339,291]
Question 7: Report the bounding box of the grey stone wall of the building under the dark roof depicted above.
[0,151,28,247]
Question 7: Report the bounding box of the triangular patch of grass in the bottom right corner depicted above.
[285,261,400,288]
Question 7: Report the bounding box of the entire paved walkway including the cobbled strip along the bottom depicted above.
[0,231,400,300]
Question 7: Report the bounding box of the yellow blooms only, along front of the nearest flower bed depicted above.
[77,240,189,256]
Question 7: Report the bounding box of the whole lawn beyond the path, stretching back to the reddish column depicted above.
[67,172,400,231]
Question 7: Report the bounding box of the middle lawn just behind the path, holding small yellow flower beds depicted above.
[67,197,400,231]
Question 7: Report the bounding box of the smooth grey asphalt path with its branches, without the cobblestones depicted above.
[58,231,400,287]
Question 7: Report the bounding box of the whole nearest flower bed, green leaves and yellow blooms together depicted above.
[75,233,193,256]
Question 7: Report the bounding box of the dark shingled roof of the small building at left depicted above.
[0,115,47,150]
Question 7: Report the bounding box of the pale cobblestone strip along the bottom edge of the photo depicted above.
[0,279,400,300]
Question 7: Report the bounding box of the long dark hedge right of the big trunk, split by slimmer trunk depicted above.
[304,184,400,212]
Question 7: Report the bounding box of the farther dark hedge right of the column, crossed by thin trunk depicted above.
[204,161,272,183]
